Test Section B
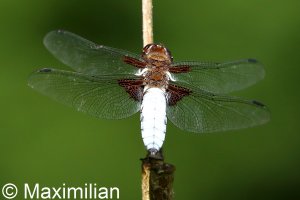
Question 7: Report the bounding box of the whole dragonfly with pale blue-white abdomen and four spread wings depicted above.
[28,30,270,155]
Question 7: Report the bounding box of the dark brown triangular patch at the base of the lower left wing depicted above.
[118,79,144,101]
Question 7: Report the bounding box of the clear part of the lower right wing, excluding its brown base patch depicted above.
[167,85,270,133]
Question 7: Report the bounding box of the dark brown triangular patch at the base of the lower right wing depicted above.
[167,84,192,106]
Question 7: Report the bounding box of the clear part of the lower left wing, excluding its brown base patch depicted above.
[28,69,140,119]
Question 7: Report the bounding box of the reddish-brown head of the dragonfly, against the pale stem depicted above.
[142,44,173,64]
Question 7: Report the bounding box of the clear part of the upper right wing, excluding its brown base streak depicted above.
[172,59,265,94]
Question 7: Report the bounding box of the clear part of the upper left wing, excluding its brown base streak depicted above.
[44,30,139,77]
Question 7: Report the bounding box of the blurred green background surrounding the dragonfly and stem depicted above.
[0,0,300,200]
